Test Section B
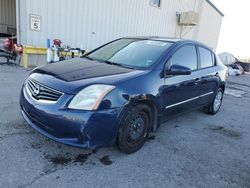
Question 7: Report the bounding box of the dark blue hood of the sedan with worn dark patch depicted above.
[30,58,145,94]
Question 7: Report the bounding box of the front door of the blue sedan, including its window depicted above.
[161,45,199,119]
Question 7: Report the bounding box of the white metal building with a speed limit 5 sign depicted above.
[0,0,223,67]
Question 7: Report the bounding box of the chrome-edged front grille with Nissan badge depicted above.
[26,78,63,102]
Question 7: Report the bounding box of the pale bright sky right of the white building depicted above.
[211,0,250,59]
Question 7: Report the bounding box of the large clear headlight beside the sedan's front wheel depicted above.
[68,84,115,110]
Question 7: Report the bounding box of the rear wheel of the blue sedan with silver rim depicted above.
[205,88,224,115]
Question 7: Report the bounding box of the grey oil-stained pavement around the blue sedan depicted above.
[0,66,250,188]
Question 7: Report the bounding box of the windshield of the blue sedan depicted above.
[86,39,172,68]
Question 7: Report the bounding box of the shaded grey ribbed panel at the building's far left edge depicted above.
[0,0,16,34]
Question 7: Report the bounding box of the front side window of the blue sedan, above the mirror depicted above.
[166,45,198,70]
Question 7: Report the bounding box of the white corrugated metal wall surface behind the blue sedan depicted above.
[20,0,223,50]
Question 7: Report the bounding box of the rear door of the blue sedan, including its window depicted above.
[197,46,219,105]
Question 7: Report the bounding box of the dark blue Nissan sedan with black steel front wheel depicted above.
[20,37,227,153]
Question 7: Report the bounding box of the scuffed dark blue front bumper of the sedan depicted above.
[20,85,122,148]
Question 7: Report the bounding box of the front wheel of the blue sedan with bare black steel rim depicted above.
[117,104,153,154]
